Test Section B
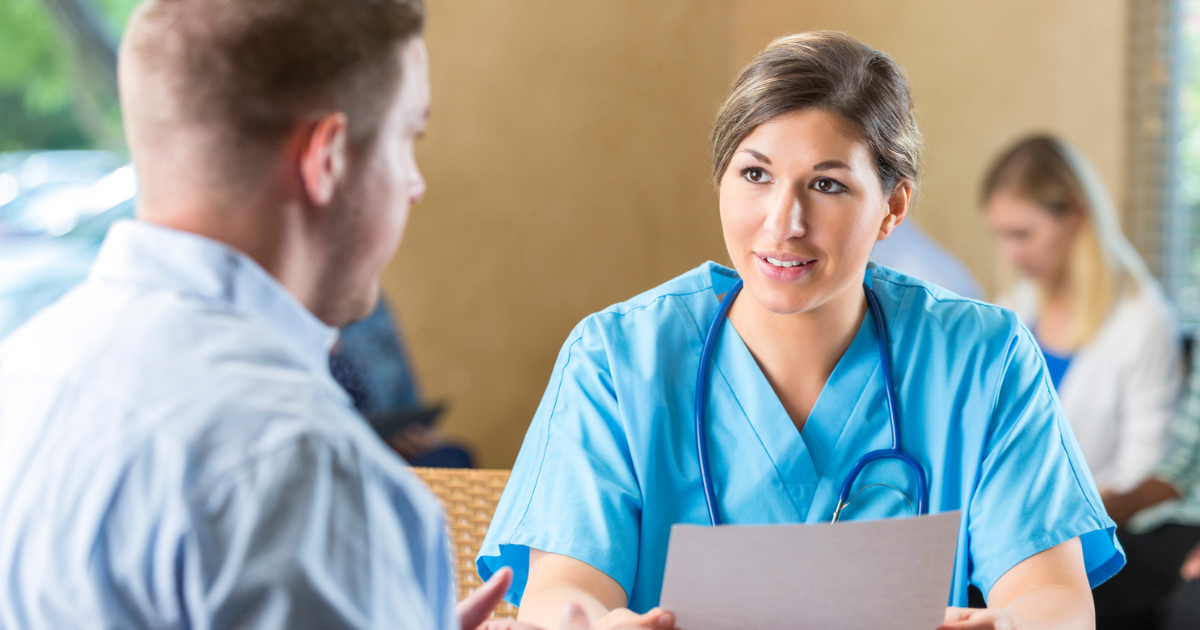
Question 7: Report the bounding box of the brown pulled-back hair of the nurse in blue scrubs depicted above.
[712,31,922,193]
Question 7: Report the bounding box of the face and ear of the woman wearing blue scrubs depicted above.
[720,109,912,314]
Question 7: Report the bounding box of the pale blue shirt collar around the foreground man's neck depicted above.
[90,221,337,374]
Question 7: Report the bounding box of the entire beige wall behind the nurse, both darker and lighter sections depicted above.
[384,0,1126,467]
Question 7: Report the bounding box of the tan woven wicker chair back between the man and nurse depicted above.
[413,468,517,618]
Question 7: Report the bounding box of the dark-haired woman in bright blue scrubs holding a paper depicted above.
[478,32,1124,629]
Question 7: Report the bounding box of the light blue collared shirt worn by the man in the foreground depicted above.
[0,222,458,630]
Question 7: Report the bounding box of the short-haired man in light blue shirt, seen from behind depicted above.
[0,0,518,630]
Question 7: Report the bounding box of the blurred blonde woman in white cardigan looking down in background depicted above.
[983,136,1182,496]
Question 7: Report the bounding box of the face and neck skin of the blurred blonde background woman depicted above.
[984,188,1085,354]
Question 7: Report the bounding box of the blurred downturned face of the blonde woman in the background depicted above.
[984,190,1080,284]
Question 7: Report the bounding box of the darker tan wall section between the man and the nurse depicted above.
[385,0,730,467]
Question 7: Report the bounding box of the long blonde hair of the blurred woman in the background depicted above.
[983,136,1159,348]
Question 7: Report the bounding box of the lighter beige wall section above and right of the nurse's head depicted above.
[730,0,1127,295]
